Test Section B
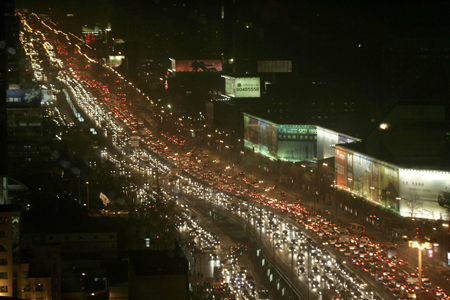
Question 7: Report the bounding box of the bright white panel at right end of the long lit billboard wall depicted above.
[399,169,450,219]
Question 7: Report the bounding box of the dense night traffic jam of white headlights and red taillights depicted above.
[22,11,450,299]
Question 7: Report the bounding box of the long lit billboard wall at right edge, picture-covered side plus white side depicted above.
[334,146,450,219]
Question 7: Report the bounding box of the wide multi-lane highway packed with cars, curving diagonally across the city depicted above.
[21,10,450,300]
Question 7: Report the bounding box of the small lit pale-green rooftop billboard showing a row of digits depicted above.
[225,77,261,98]
